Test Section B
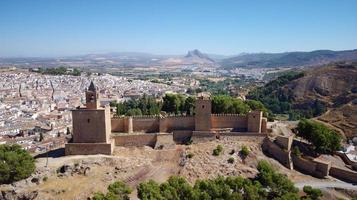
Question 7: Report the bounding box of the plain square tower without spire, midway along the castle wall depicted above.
[195,95,212,131]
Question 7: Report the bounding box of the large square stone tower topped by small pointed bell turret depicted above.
[66,82,114,155]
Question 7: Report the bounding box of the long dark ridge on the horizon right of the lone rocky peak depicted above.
[219,49,357,68]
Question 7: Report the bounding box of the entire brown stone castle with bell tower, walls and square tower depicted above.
[65,82,267,155]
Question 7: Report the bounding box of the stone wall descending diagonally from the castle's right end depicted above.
[262,138,292,169]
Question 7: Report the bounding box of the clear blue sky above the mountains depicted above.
[0,0,357,57]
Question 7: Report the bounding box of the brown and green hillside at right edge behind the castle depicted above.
[248,63,357,136]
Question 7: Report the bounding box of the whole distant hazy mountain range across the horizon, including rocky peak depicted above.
[0,49,357,69]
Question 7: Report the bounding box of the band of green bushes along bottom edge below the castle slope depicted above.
[92,161,321,200]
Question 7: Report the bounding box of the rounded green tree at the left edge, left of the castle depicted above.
[0,144,35,184]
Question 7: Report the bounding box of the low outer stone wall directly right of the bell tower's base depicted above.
[113,134,157,147]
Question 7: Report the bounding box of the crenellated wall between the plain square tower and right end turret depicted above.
[211,114,247,131]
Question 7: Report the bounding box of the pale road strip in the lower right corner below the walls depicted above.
[295,181,357,190]
